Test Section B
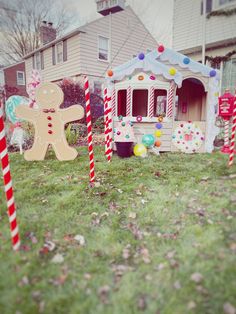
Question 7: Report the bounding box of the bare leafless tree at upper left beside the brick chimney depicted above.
[0,0,75,63]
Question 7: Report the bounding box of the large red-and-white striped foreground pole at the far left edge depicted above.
[0,109,20,251]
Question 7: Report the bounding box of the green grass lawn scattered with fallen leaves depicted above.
[0,147,236,314]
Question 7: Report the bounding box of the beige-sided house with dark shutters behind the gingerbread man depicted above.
[25,7,157,91]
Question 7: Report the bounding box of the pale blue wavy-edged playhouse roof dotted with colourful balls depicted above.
[107,46,220,87]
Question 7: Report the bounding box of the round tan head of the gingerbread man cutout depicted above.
[36,83,64,109]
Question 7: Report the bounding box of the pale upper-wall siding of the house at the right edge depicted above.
[173,0,236,51]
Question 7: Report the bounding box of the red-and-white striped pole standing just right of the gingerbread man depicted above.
[84,76,95,183]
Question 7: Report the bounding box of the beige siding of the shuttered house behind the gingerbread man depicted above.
[26,7,157,81]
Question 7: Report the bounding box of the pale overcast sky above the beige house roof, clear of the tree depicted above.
[61,0,174,47]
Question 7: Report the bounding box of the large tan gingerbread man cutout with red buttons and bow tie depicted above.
[16,83,84,161]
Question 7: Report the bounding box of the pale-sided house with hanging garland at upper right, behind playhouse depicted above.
[173,0,236,92]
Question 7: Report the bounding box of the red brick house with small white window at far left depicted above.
[3,62,28,99]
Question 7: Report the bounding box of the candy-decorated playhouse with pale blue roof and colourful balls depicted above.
[106,45,220,153]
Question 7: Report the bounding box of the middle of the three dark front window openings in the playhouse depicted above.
[132,89,148,117]
